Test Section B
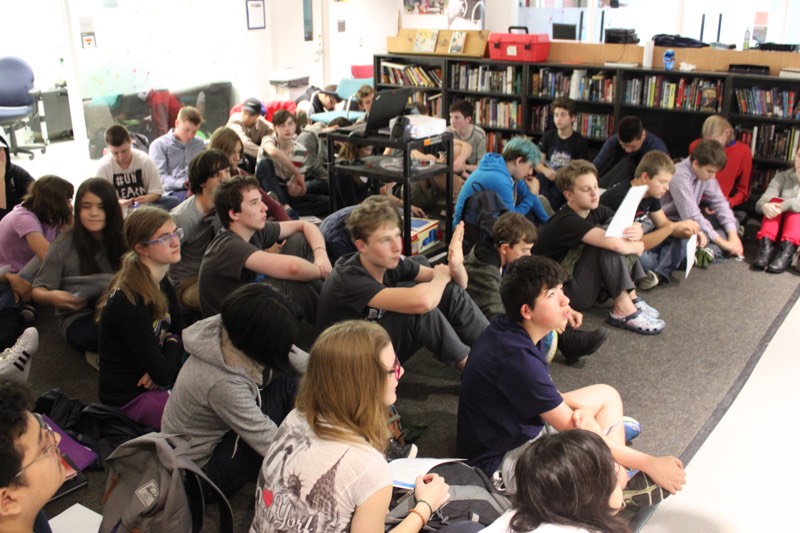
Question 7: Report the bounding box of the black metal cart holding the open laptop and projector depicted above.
[328,131,453,256]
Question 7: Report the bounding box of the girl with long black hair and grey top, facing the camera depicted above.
[33,178,126,352]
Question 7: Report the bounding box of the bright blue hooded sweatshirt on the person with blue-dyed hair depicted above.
[453,152,550,224]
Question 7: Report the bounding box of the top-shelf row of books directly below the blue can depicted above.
[625,75,722,112]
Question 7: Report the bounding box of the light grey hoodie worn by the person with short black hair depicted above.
[161,315,278,466]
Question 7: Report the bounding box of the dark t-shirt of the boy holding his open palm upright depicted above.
[317,252,420,331]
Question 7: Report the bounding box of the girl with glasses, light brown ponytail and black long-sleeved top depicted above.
[96,206,183,429]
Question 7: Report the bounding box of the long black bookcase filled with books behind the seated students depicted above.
[374,54,800,192]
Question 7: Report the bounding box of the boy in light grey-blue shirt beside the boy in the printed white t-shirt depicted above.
[150,106,205,202]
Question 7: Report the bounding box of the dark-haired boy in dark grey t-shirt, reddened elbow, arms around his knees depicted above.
[198,176,331,323]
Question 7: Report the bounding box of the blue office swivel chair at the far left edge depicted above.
[0,57,45,159]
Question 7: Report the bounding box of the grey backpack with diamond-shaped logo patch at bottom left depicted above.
[100,433,233,533]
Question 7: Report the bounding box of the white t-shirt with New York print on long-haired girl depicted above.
[250,409,392,533]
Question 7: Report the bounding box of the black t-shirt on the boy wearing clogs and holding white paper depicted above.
[532,205,614,263]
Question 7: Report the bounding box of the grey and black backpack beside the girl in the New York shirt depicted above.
[386,462,511,531]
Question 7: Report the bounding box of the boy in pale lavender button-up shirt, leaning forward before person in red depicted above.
[661,140,744,257]
